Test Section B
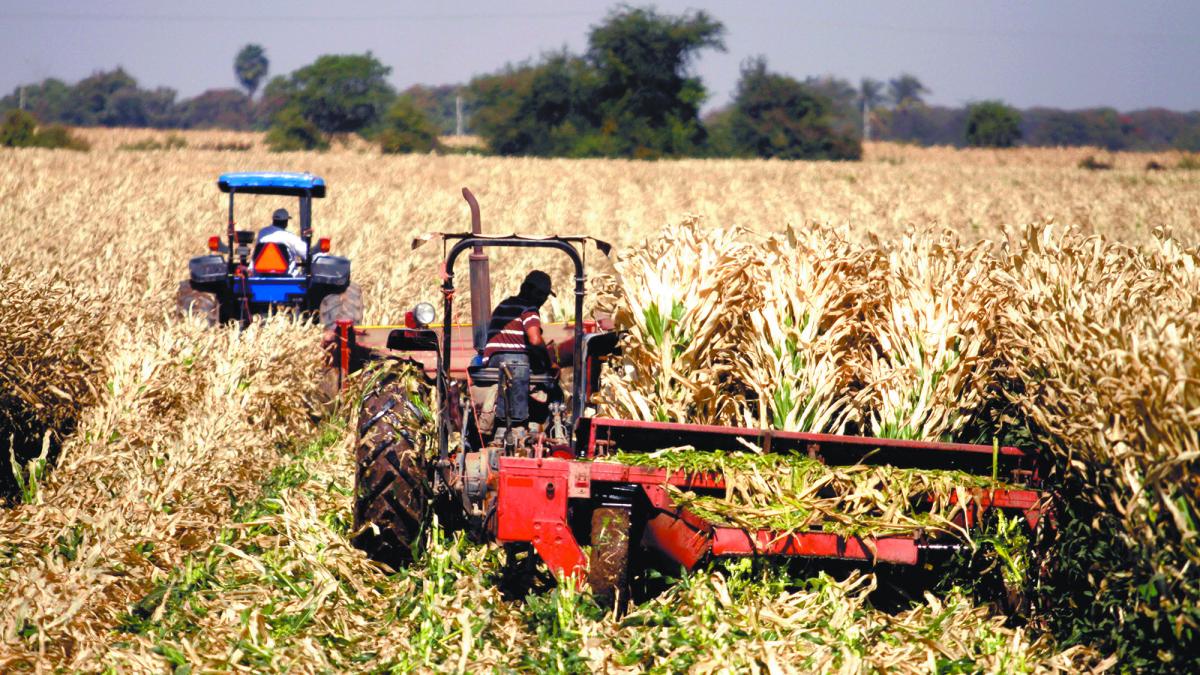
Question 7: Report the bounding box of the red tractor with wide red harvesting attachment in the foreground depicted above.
[335,190,1046,599]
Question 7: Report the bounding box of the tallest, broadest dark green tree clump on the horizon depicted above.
[468,7,725,157]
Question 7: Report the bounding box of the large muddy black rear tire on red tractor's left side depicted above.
[352,381,432,569]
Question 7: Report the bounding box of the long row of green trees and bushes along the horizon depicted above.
[0,6,1200,160]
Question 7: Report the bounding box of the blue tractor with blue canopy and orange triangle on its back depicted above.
[175,172,362,327]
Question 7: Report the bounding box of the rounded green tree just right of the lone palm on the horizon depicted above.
[292,52,396,133]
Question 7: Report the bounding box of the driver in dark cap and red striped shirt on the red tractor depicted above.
[484,269,558,426]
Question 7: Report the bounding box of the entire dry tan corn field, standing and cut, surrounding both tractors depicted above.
[0,130,1200,673]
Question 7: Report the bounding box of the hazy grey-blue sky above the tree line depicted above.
[0,0,1200,110]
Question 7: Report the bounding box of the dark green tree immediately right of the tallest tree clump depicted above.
[728,56,863,160]
